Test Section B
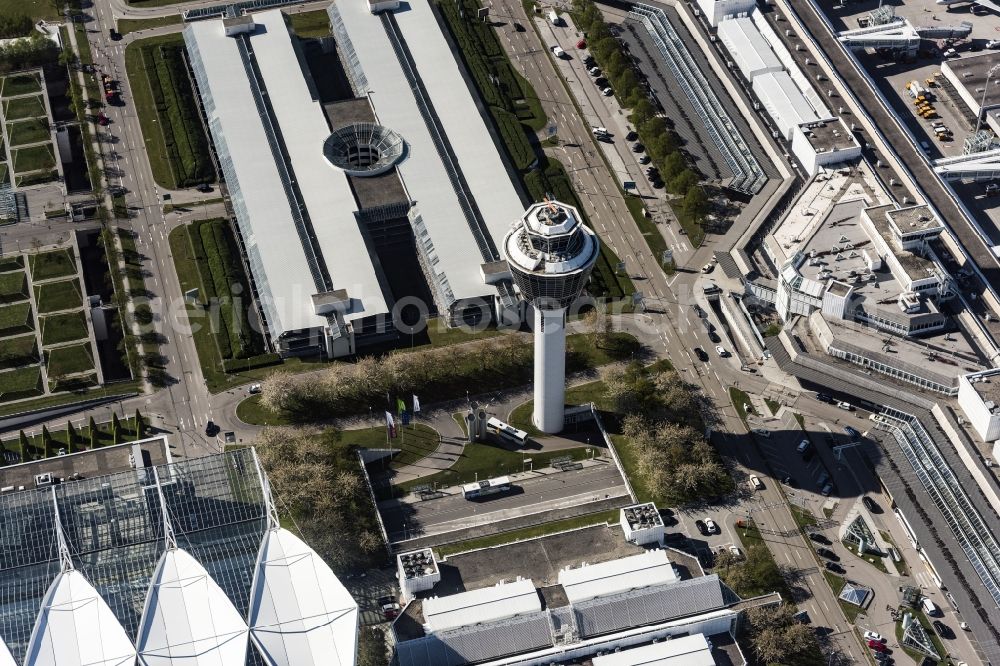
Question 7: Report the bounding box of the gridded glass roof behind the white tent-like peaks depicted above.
[0,449,268,664]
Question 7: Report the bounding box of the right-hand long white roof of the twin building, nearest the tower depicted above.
[336,0,524,299]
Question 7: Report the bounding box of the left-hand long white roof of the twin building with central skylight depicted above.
[186,10,388,335]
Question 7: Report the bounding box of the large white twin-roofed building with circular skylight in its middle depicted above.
[184,0,524,357]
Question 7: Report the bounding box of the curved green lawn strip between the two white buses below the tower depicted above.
[393,440,593,491]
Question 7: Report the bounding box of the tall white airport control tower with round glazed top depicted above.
[503,201,600,433]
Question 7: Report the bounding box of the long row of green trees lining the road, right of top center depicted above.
[573,0,708,233]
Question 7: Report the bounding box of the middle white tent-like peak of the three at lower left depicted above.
[136,548,249,666]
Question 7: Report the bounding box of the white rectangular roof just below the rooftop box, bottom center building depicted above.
[559,550,677,604]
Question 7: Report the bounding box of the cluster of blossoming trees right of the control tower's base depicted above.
[604,363,734,505]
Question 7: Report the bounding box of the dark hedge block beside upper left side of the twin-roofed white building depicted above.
[141,46,214,187]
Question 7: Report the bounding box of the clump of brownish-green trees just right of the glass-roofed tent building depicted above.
[255,428,384,574]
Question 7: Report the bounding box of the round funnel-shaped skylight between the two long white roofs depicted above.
[323,123,406,177]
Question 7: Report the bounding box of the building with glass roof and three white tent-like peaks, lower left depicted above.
[0,438,358,666]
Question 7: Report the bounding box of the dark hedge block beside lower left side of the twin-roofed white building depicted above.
[196,220,258,359]
